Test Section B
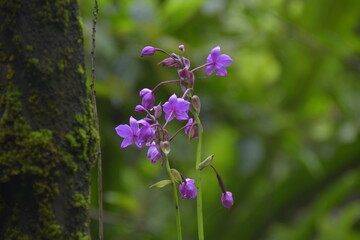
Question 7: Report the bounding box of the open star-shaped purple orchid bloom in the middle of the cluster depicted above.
[163,94,190,122]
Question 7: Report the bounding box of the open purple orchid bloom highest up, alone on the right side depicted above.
[206,46,232,76]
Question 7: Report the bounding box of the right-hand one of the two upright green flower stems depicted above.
[192,111,204,240]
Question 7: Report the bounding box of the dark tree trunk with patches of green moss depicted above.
[0,0,97,240]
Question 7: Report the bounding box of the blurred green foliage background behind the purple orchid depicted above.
[79,0,360,240]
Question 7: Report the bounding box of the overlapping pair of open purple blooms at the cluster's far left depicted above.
[115,116,154,148]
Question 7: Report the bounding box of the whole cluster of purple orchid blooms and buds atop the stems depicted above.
[115,45,234,238]
